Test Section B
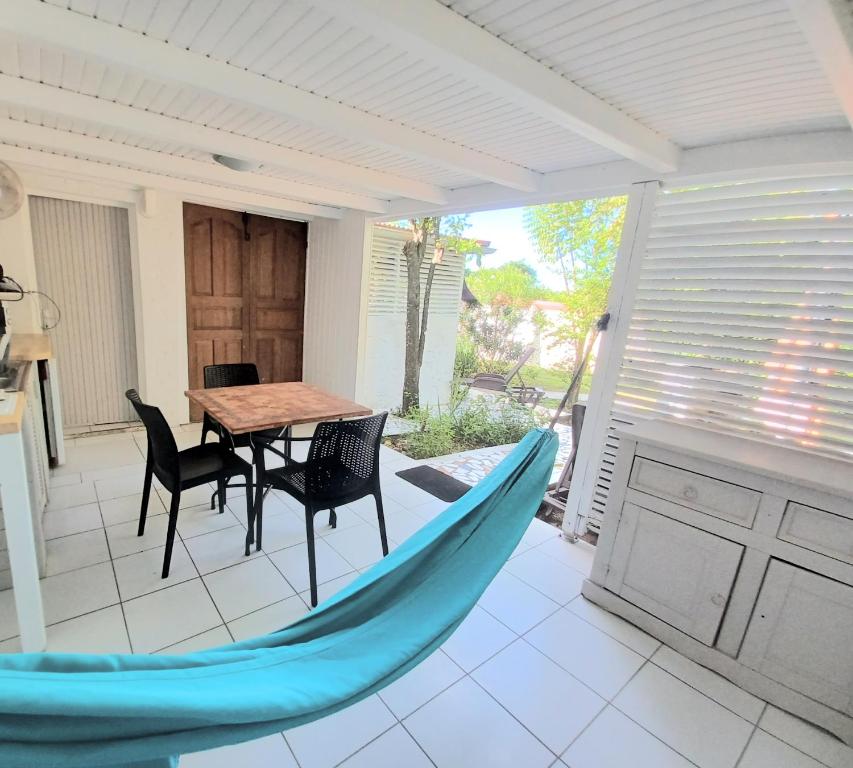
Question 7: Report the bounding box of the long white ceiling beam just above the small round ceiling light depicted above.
[0,75,447,204]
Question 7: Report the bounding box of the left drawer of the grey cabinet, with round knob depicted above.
[628,456,761,528]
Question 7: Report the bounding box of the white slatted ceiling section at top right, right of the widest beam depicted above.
[442,0,846,147]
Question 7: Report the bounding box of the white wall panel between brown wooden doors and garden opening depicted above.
[302,211,367,400]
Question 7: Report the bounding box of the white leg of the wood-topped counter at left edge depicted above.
[0,432,47,653]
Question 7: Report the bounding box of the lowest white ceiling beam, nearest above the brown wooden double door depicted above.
[0,143,343,220]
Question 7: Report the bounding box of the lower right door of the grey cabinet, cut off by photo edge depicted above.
[738,560,853,715]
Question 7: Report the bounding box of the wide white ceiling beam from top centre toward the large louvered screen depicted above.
[312,0,679,172]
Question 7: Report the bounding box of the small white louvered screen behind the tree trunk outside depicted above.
[368,225,465,315]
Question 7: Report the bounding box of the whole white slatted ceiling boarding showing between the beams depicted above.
[0,0,847,207]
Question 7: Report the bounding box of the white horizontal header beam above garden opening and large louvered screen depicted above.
[386,130,853,219]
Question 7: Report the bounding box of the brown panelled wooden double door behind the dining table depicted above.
[184,203,308,421]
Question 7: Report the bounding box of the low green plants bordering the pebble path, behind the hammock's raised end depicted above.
[387,397,540,459]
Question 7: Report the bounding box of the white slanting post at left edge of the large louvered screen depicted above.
[563,181,660,540]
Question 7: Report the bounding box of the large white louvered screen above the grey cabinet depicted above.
[590,176,853,528]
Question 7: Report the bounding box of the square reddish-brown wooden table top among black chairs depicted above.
[184,381,373,435]
